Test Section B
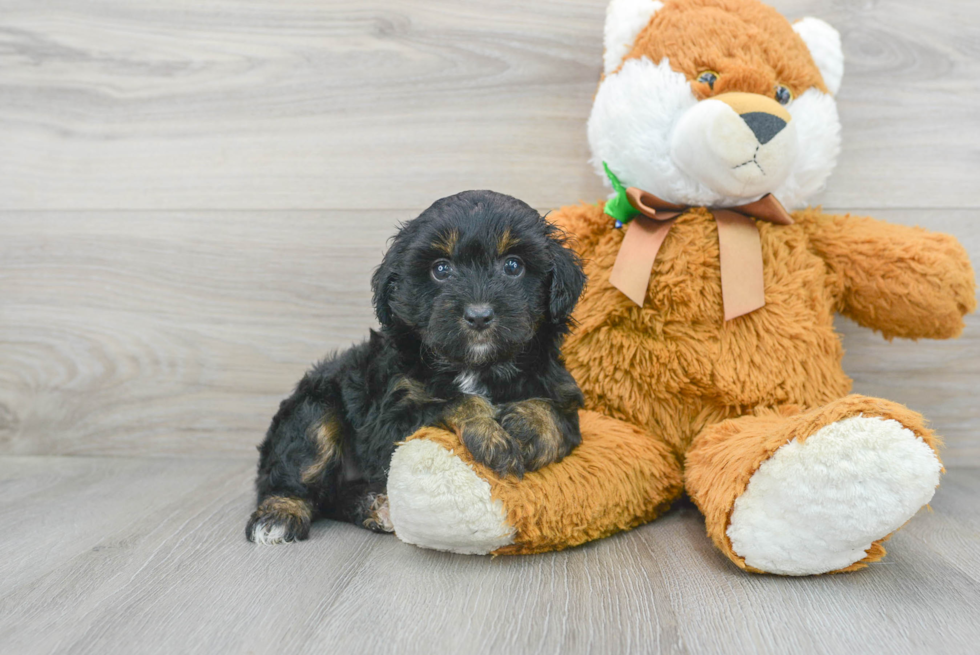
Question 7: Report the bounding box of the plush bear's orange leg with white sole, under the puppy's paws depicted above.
[388,412,683,554]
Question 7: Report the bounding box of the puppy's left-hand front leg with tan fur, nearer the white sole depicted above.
[443,395,524,477]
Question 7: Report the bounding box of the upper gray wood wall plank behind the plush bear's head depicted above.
[0,0,980,209]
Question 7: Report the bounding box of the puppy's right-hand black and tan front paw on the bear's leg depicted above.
[499,400,571,471]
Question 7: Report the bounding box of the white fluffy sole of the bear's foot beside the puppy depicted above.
[388,439,514,555]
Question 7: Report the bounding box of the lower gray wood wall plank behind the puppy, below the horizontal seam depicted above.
[0,210,980,464]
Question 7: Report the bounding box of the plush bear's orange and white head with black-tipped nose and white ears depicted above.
[588,0,844,207]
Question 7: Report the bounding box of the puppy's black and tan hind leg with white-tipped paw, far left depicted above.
[245,392,342,544]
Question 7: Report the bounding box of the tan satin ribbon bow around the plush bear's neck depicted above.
[609,187,793,321]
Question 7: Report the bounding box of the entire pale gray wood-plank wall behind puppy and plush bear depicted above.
[0,0,980,466]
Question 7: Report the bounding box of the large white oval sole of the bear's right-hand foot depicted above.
[727,416,942,575]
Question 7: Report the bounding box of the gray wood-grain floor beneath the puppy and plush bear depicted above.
[0,457,980,655]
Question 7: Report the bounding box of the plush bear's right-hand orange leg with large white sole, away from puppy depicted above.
[685,395,943,575]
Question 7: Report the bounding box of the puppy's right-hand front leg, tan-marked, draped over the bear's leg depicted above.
[498,398,582,471]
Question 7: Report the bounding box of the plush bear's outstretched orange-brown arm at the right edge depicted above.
[793,209,977,339]
